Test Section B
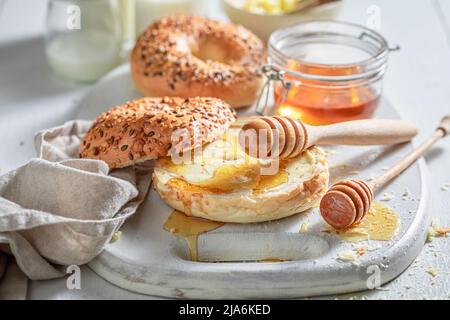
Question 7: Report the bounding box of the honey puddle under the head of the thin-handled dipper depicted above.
[336,203,399,242]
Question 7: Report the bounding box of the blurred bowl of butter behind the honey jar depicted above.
[221,0,342,41]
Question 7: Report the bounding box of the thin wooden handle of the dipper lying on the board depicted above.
[368,116,450,191]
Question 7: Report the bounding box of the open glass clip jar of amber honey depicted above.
[257,21,389,125]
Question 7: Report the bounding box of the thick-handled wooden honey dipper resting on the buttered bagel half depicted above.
[239,116,417,159]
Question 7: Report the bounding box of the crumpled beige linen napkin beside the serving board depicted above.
[0,121,152,284]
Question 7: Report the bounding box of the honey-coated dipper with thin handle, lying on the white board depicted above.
[320,115,450,229]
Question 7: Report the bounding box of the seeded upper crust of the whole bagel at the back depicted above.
[134,15,266,87]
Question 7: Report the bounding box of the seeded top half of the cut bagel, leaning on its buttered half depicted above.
[80,97,235,169]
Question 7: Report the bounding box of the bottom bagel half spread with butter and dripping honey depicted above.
[153,127,329,223]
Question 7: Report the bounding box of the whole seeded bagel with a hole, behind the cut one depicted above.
[131,15,266,108]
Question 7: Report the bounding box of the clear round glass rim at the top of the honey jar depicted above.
[269,20,389,82]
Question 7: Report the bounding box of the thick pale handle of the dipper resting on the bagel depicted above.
[305,119,418,147]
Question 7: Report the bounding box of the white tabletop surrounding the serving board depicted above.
[0,0,450,299]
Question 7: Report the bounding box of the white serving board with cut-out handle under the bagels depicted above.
[78,65,430,298]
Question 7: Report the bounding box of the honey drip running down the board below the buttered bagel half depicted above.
[164,210,225,261]
